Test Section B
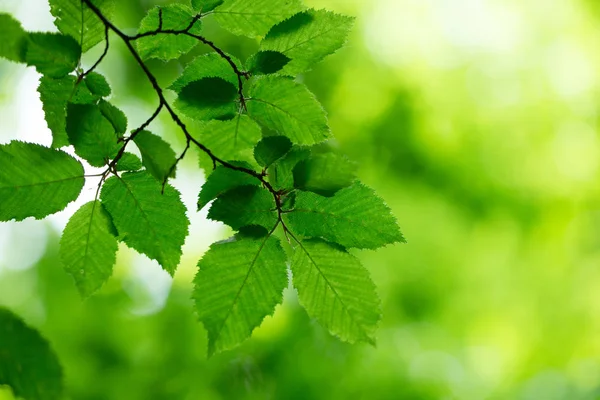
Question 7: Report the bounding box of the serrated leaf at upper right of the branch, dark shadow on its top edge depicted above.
[260,10,354,75]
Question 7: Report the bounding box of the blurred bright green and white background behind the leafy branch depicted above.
[0,0,600,400]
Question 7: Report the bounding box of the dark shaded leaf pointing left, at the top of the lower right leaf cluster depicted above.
[198,163,260,211]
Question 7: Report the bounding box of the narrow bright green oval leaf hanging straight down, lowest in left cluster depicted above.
[60,201,118,297]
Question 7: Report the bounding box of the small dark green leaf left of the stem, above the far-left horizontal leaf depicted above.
[67,104,120,167]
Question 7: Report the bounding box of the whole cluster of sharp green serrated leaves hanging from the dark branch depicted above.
[0,0,404,392]
